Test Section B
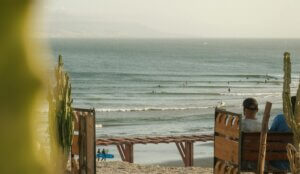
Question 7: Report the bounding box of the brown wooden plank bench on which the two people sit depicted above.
[214,109,293,174]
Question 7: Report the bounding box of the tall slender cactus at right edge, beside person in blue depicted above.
[282,52,300,173]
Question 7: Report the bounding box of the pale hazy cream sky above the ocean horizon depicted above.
[42,0,300,38]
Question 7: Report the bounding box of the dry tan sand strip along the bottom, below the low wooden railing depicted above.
[96,161,213,174]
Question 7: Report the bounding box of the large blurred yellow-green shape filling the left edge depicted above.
[0,0,54,174]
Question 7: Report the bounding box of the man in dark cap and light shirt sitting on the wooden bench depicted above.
[242,98,261,132]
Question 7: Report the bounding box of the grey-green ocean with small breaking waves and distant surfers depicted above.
[49,39,300,163]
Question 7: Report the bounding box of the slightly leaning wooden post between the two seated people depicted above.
[257,102,272,174]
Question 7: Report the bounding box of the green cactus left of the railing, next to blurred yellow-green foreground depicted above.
[48,55,73,168]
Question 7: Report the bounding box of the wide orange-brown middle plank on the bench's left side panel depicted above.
[214,136,238,164]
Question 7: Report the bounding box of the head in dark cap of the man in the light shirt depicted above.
[243,98,258,119]
